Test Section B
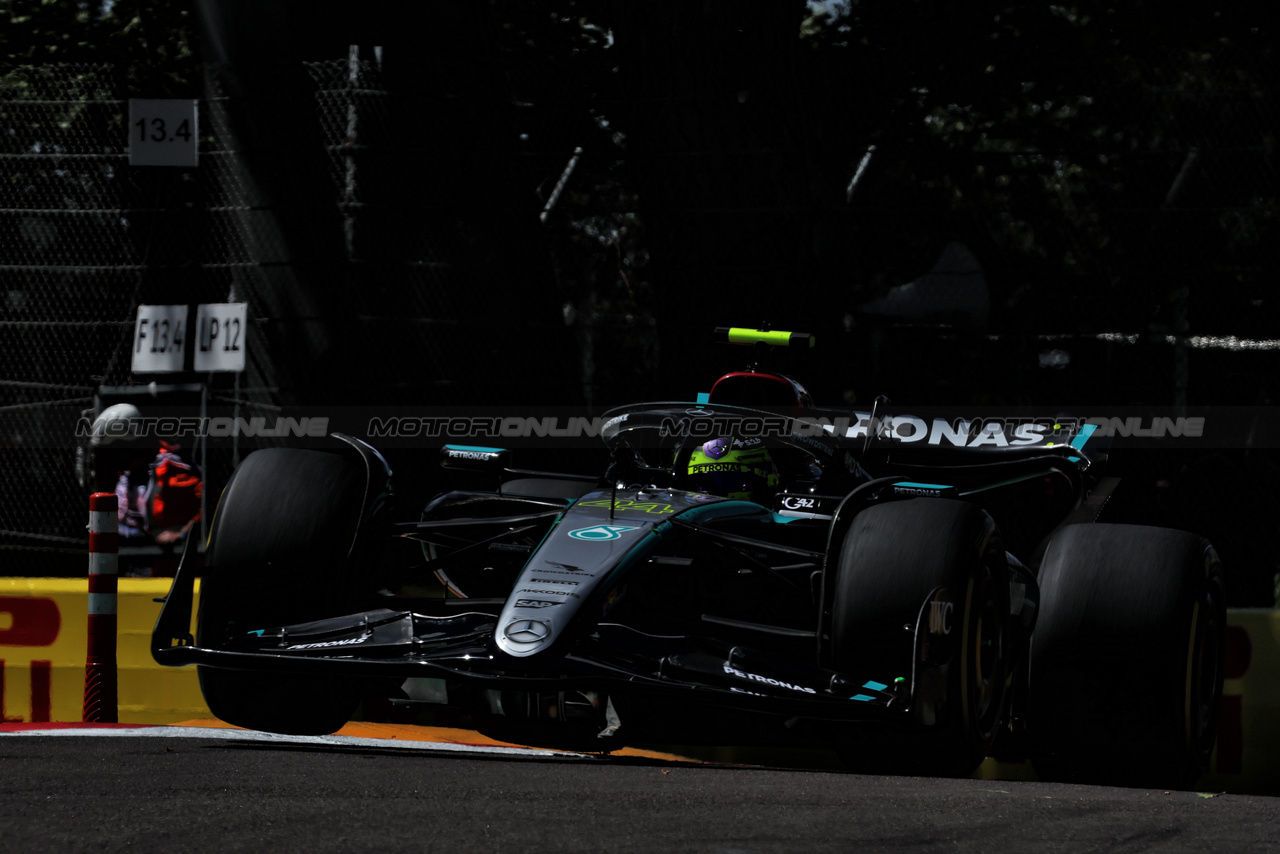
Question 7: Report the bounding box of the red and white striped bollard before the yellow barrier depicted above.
[83,492,120,723]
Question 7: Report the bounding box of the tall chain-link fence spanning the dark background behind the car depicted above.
[0,20,1280,599]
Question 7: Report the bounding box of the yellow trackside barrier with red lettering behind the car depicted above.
[0,579,1280,793]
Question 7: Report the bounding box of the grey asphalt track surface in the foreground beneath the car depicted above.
[0,727,1280,854]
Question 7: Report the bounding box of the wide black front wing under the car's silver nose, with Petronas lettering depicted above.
[152,594,942,726]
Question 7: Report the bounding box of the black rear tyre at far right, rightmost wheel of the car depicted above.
[1029,524,1226,789]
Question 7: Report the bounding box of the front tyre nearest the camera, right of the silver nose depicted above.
[831,498,1009,776]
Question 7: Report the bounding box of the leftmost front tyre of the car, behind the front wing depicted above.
[197,448,365,735]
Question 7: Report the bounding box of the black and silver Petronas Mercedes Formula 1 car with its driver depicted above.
[152,329,1226,787]
